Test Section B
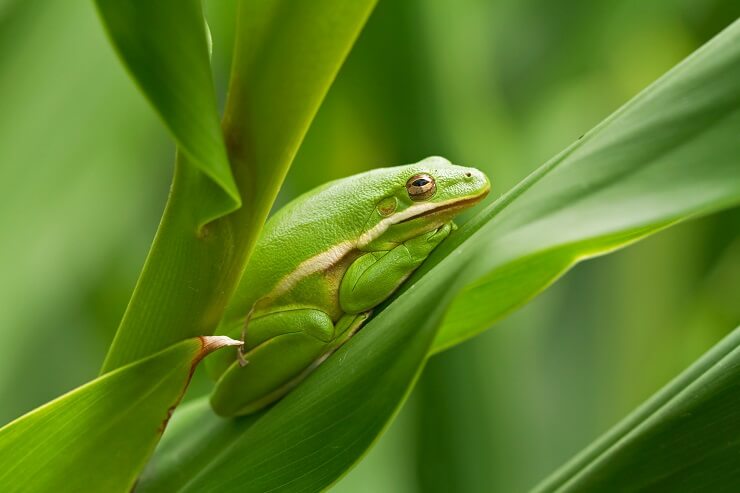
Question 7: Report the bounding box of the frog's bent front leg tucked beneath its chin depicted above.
[339,223,453,313]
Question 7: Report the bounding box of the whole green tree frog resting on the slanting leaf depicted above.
[208,157,490,416]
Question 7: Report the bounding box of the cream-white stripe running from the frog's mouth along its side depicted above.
[267,199,450,298]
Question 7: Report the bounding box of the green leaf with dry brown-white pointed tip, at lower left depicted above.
[0,336,239,492]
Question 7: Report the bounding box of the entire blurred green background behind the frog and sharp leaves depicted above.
[0,0,740,492]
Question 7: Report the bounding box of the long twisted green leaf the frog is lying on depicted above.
[142,18,740,491]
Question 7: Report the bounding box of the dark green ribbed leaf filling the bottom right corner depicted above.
[536,328,740,493]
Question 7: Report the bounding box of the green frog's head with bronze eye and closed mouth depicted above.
[359,156,491,249]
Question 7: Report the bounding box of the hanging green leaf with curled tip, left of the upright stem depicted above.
[95,0,241,227]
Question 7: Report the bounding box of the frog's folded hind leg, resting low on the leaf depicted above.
[211,308,334,416]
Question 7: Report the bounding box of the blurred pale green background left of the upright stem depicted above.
[0,0,172,423]
